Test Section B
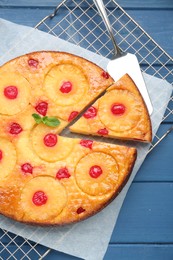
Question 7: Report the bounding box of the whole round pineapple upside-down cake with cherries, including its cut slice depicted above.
[0,51,151,225]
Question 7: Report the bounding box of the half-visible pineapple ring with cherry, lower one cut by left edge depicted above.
[0,138,16,181]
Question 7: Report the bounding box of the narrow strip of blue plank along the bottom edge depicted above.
[0,244,173,260]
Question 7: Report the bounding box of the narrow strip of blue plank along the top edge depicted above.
[0,0,173,9]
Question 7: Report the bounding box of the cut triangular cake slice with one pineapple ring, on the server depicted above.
[70,74,152,142]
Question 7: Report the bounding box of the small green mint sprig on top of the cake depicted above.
[32,114,61,127]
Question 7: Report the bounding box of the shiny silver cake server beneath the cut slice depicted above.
[93,0,153,115]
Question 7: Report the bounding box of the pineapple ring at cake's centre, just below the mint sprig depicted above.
[31,124,76,162]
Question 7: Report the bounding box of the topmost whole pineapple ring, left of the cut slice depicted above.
[44,64,88,106]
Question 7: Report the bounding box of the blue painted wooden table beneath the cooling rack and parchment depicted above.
[0,0,173,260]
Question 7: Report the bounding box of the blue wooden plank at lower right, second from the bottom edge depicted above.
[111,182,173,244]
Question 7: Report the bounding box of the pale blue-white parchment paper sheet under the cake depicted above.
[0,19,172,260]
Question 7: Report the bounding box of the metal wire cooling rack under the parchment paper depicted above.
[0,0,173,260]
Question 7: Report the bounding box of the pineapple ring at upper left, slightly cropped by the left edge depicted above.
[0,72,31,115]
